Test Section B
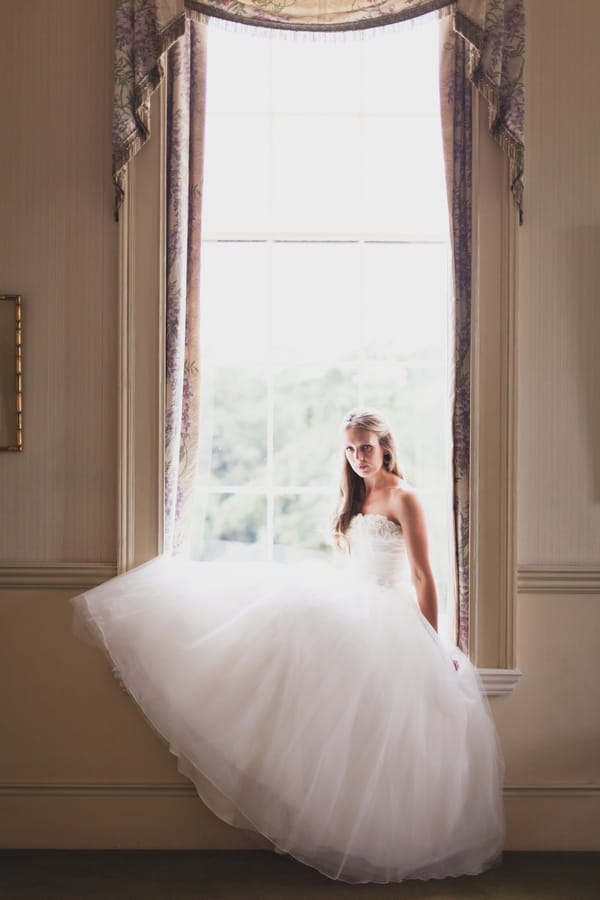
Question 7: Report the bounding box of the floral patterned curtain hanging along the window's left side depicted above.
[164,21,206,553]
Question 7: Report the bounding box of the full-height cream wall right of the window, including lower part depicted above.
[494,0,600,849]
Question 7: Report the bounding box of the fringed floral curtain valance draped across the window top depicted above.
[113,0,525,216]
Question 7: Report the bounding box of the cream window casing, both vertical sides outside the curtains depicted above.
[117,82,520,695]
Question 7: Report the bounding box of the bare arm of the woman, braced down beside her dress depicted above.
[394,491,438,631]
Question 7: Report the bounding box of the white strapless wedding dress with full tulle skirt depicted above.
[74,514,504,882]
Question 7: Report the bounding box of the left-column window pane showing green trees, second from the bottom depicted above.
[199,368,267,486]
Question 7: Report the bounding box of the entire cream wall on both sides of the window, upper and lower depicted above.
[0,0,600,849]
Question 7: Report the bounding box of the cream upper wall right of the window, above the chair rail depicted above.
[518,0,600,564]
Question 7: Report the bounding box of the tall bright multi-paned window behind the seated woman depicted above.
[194,19,451,636]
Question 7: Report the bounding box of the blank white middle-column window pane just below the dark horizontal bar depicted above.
[272,243,360,365]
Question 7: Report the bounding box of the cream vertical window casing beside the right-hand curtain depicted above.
[469,93,518,669]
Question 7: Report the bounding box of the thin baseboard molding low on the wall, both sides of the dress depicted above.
[0,781,600,800]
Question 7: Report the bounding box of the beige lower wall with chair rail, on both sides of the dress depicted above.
[0,563,600,850]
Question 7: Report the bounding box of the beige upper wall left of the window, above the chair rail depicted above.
[0,0,117,562]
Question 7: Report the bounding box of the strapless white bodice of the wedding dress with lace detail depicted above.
[347,513,410,587]
